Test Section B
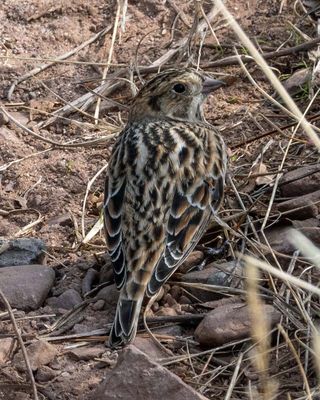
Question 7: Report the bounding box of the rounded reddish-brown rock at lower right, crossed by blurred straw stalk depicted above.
[194,303,281,346]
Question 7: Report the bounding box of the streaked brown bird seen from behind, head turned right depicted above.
[103,68,227,348]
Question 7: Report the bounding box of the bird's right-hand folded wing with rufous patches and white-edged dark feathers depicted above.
[147,177,224,297]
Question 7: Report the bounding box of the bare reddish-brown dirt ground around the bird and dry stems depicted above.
[0,0,320,400]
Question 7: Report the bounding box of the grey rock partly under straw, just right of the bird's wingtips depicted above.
[181,261,243,302]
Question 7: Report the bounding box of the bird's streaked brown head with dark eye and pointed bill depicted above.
[129,69,224,122]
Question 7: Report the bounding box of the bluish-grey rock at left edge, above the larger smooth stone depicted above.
[0,238,46,267]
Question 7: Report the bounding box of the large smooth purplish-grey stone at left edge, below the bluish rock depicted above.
[0,265,55,310]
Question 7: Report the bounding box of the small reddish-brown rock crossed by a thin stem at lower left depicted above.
[14,340,58,371]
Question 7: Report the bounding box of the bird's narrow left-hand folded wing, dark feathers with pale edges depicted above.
[104,141,126,289]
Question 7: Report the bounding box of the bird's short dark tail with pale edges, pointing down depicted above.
[109,295,142,347]
